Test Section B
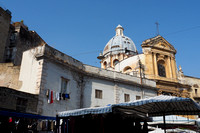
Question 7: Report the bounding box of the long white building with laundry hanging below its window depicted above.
[19,45,157,116]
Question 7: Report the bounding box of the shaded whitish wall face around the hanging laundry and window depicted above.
[40,60,82,116]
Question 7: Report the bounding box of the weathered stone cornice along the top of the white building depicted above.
[35,45,157,90]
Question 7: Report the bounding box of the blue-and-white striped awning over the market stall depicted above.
[58,95,200,117]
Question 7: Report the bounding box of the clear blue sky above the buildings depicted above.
[0,0,200,78]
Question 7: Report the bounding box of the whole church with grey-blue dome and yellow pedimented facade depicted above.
[97,25,200,102]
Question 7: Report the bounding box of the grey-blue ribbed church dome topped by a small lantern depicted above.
[103,25,137,56]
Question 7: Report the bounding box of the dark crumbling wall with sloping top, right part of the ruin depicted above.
[4,21,46,65]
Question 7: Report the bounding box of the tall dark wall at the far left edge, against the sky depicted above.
[0,7,11,62]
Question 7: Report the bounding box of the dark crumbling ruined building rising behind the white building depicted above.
[0,7,46,65]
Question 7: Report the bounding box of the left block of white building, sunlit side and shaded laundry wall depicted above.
[20,45,84,116]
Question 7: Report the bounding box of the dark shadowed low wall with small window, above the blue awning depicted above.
[0,87,38,114]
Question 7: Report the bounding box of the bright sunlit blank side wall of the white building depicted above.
[19,46,44,94]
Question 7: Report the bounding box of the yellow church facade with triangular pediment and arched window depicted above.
[141,35,190,97]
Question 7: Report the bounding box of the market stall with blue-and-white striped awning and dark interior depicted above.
[56,95,200,133]
